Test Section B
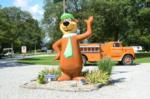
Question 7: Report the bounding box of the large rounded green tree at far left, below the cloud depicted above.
[0,7,42,50]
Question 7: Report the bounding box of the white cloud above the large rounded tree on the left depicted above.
[14,0,44,20]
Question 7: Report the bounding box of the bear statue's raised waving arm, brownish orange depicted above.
[77,16,93,40]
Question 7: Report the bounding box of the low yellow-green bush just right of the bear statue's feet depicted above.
[85,70,109,84]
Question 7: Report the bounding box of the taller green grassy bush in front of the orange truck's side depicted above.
[97,58,114,75]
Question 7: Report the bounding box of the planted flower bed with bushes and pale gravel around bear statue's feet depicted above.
[22,58,113,92]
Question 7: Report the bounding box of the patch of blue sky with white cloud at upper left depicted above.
[0,0,44,20]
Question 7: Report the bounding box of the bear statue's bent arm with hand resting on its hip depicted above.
[53,39,61,60]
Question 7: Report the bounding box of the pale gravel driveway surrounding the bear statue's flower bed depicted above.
[0,63,150,99]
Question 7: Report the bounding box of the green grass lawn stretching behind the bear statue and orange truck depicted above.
[18,56,150,65]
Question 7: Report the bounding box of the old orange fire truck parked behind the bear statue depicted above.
[80,42,135,65]
